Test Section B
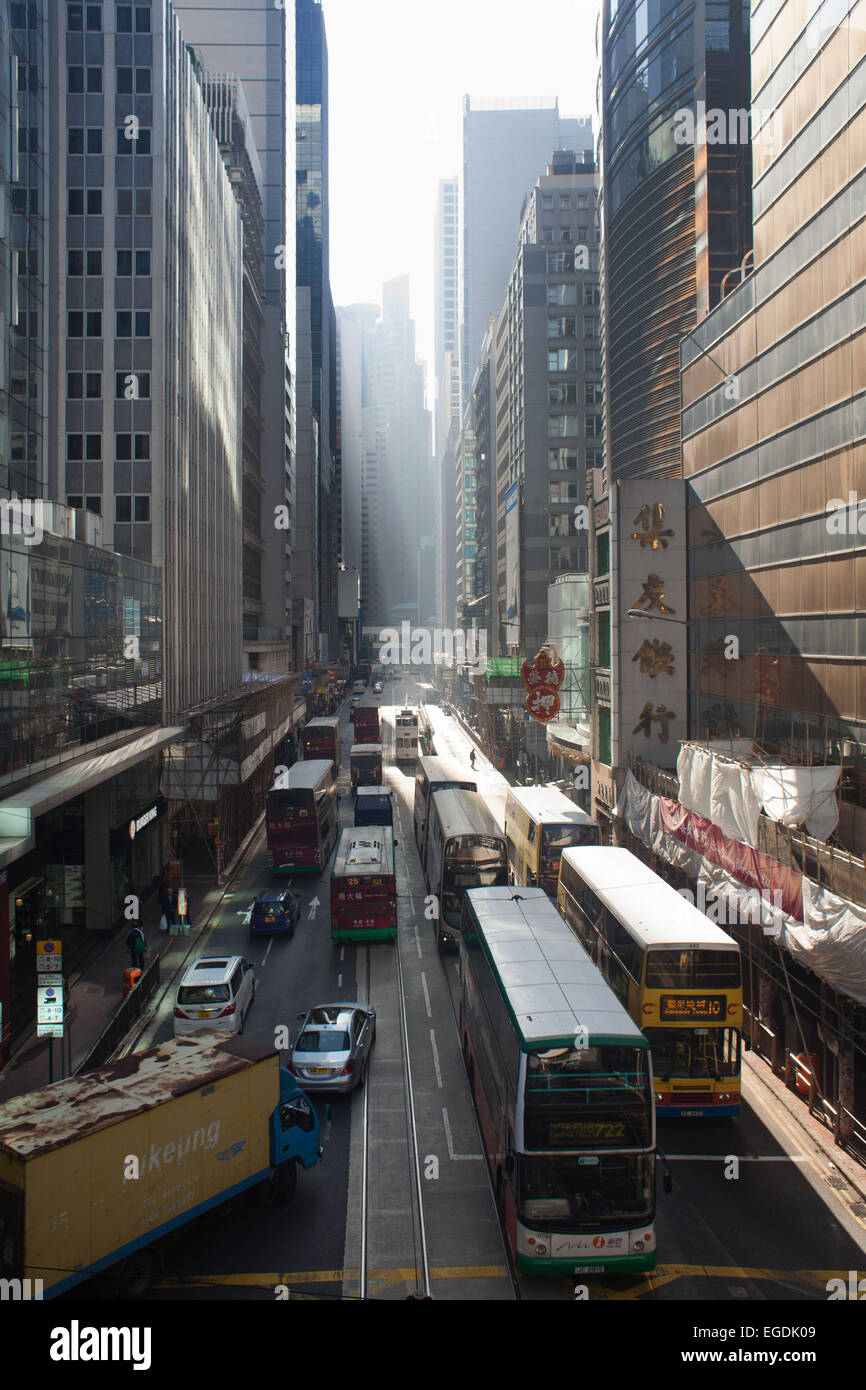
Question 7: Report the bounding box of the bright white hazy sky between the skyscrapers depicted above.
[322,0,596,400]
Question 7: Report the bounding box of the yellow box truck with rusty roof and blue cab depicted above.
[0,1030,321,1298]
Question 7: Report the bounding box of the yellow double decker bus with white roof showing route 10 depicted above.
[557,845,742,1116]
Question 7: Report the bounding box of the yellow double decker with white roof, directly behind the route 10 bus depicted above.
[505,787,601,902]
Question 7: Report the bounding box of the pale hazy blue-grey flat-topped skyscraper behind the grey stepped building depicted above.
[459,96,592,409]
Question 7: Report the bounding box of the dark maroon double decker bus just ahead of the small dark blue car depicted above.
[265,759,339,873]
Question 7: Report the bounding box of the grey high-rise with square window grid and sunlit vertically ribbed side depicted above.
[50,6,242,721]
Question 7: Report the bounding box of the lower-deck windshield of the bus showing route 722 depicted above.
[517,1154,653,1229]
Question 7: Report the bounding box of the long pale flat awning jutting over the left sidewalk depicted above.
[0,726,183,869]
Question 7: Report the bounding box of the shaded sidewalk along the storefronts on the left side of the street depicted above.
[0,821,260,1105]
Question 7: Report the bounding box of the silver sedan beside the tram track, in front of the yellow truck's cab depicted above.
[289,1004,375,1091]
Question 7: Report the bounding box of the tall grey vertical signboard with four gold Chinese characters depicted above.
[617,478,688,767]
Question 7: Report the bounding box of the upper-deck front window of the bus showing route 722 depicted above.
[524,1044,652,1150]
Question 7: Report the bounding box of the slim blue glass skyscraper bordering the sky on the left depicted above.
[295,0,339,655]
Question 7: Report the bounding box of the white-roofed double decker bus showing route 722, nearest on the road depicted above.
[460,887,656,1275]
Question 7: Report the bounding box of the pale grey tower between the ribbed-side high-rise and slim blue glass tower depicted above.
[172,0,303,670]
